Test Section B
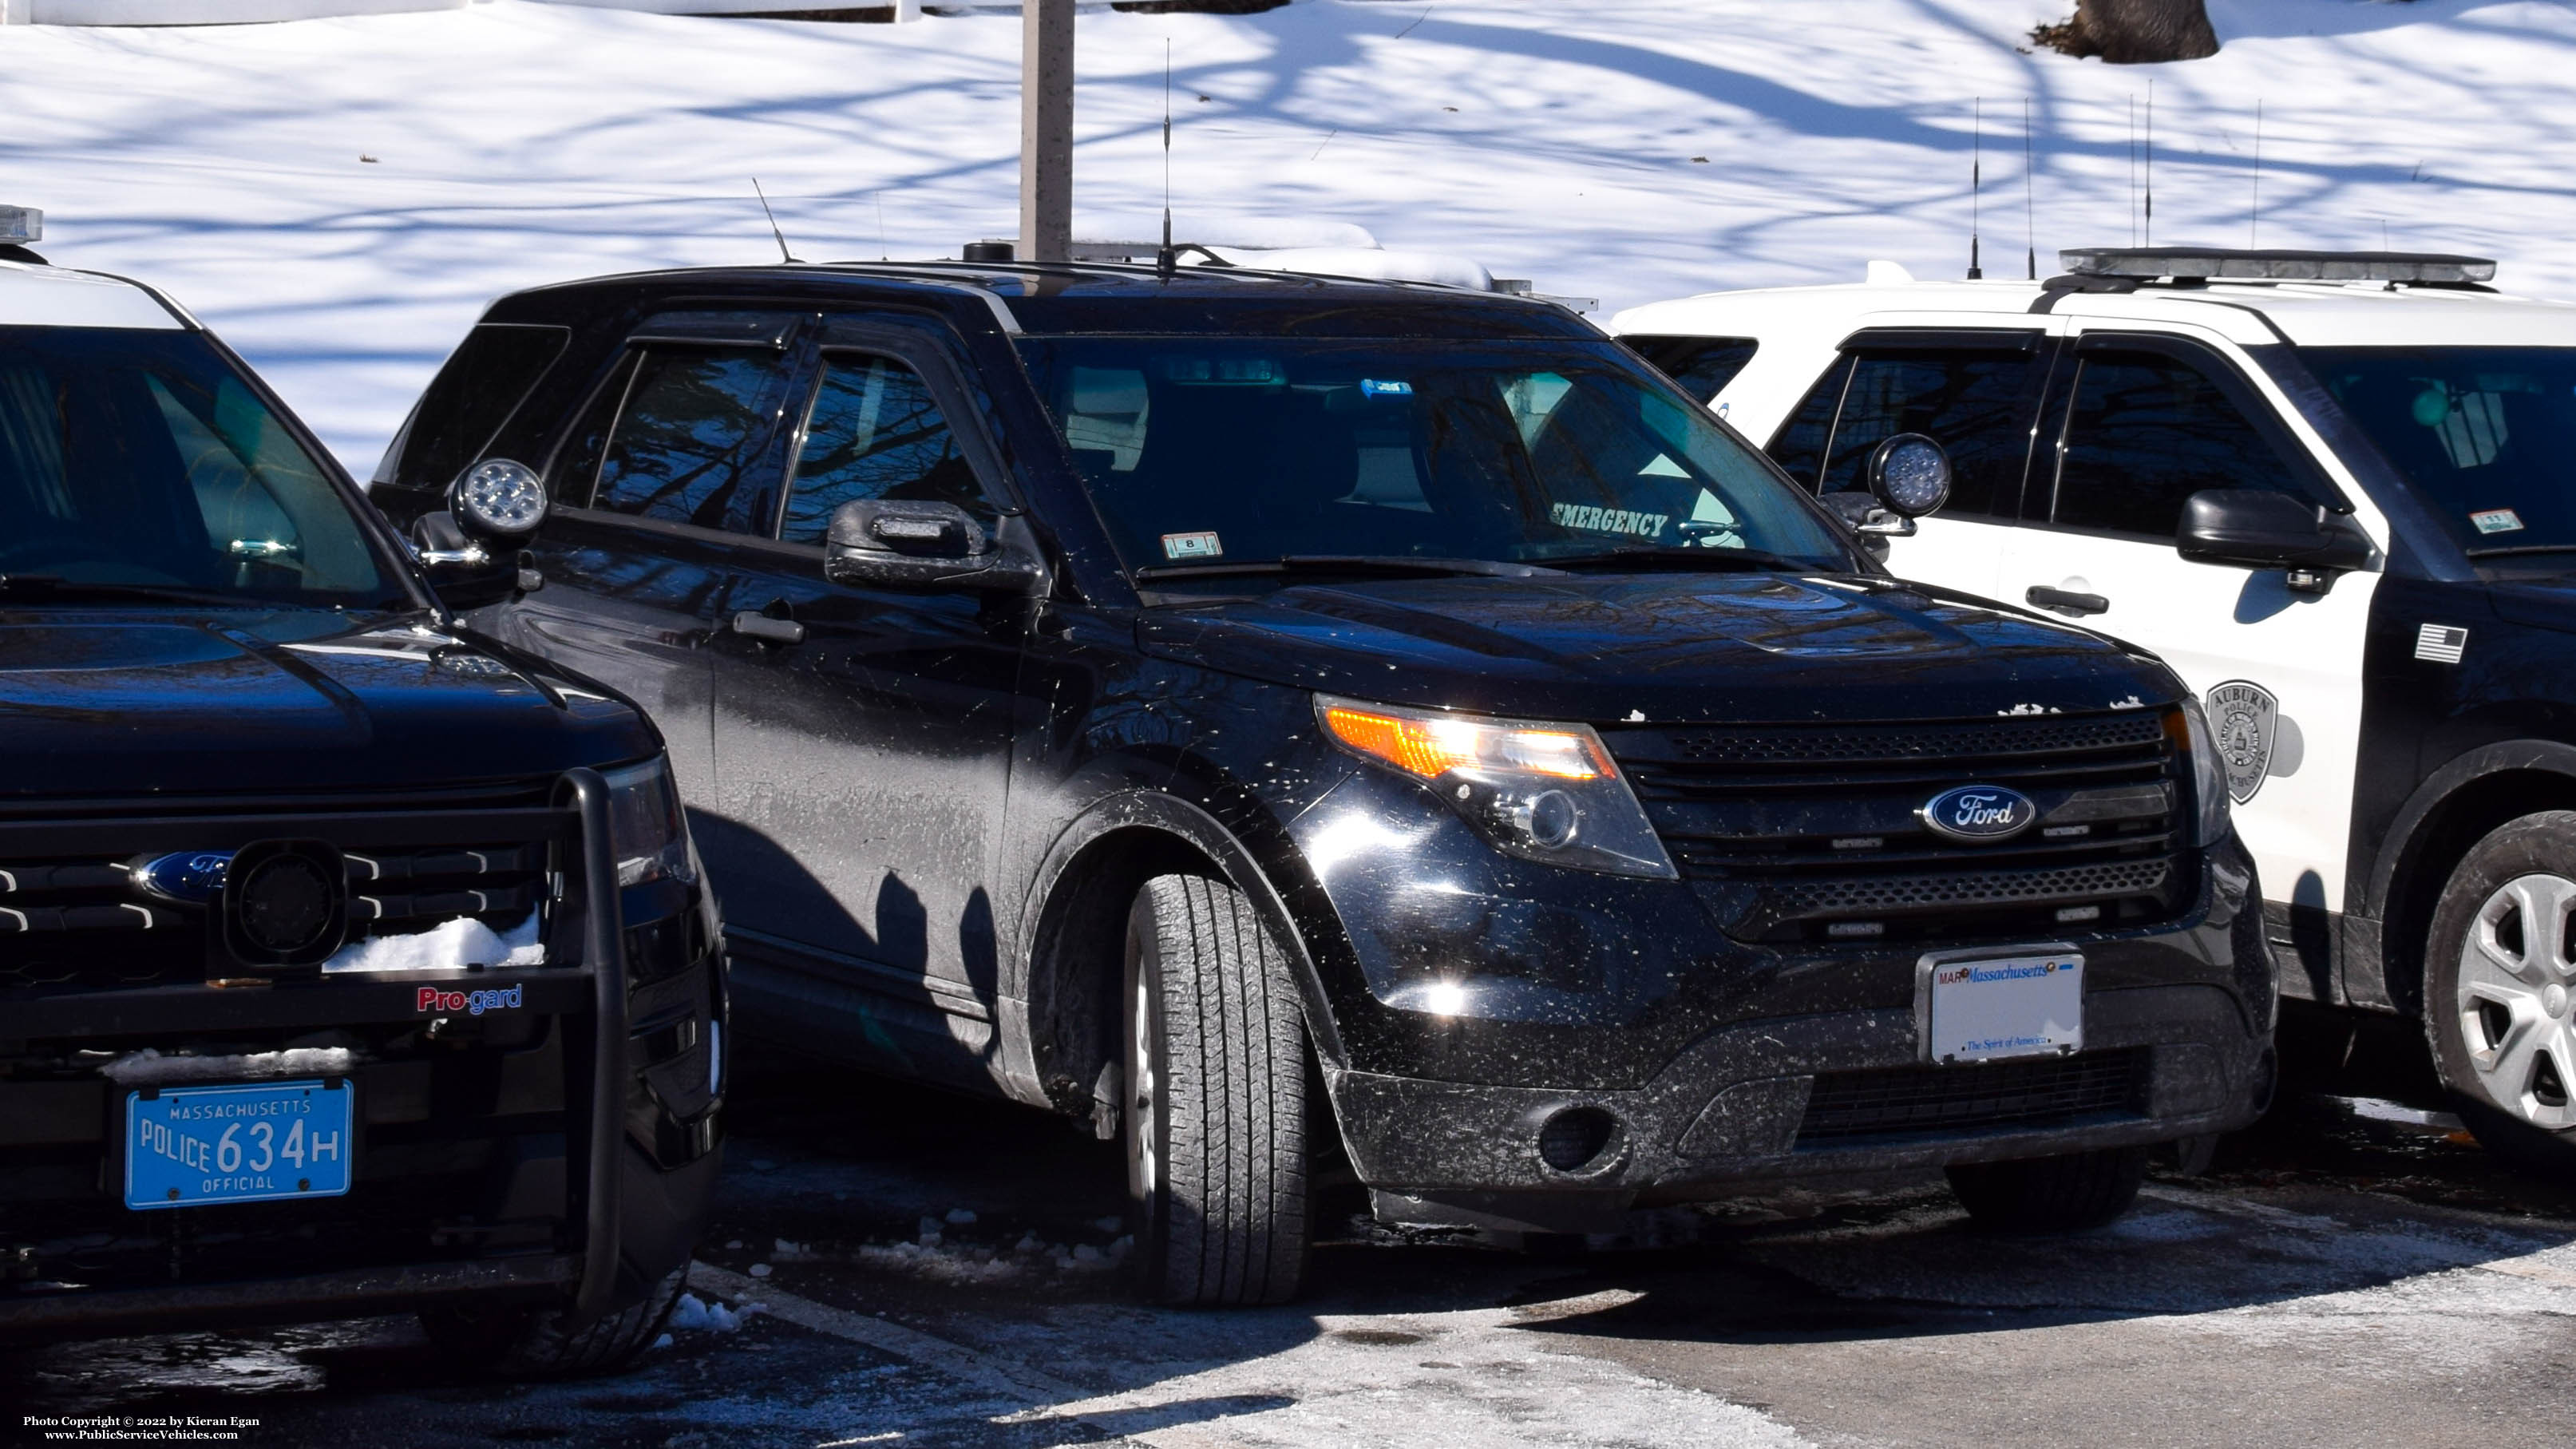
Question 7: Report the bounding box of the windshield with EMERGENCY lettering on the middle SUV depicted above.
[1020,338,1852,575]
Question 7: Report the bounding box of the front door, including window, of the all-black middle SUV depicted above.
[714,317,1031,1031]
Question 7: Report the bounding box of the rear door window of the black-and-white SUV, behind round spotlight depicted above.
[1821,348,2040,518]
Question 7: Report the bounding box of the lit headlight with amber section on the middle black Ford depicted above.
[1314,694,1680,879]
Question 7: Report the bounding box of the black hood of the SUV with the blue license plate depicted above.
[0,611,659,797]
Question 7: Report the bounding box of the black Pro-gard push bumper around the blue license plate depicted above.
[0,768,724,1340]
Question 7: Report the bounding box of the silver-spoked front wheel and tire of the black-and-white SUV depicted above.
[2424,810,2576,1176]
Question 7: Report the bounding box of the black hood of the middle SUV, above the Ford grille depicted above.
[1138,575,2182,725]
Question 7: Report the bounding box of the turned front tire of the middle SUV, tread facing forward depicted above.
[1121,877,1308,1304]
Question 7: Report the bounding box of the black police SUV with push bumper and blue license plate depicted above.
[0,231,726,1374]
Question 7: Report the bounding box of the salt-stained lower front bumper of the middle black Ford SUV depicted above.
[1327,985,2272,1233]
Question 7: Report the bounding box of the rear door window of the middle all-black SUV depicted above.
[590,346,785,534]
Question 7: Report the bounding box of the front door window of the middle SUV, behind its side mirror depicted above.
[778,353,997,544]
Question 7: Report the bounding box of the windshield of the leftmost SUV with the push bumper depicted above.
[0,327,402,604]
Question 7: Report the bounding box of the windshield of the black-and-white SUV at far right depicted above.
[2301,348,2576,564]
